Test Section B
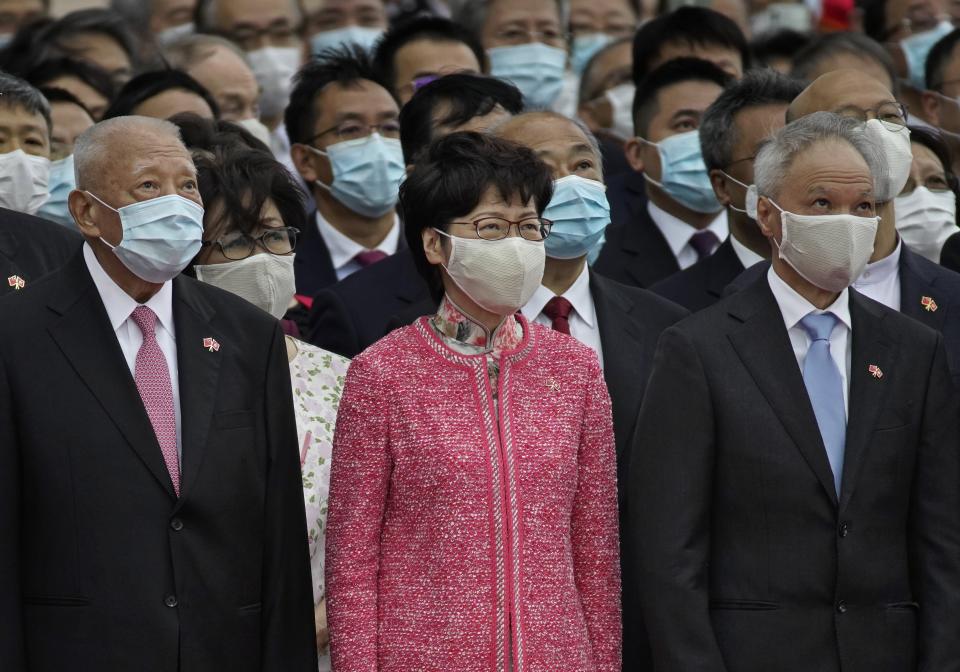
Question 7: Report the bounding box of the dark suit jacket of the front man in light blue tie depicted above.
[629,278,960,672]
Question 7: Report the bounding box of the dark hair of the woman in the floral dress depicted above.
[188,147,307,263]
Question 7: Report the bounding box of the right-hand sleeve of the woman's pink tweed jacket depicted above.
[571,360,622,672]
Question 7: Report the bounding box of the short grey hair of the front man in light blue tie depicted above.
[753,112,886,199]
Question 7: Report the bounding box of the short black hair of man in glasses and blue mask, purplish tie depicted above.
[283,44,387,144]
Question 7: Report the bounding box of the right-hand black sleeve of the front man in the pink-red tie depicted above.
[261,325,317,672]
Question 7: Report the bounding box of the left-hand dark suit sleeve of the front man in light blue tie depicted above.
[624,327,725,672]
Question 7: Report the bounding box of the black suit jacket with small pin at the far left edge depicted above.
[0,208,82,296]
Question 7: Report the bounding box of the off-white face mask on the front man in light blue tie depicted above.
[767,194,880,292]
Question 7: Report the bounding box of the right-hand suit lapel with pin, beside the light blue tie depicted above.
[840,290,896,508]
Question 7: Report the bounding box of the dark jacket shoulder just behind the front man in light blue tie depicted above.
[650,238,743,312]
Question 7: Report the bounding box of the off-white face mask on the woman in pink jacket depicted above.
[434,229,547,315]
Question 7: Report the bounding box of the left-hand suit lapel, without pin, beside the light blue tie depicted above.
[729,276,837,505]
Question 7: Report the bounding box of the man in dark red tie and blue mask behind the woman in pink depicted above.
[494,112,687,671]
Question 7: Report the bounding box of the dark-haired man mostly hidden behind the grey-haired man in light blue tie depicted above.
[650,69,803,311]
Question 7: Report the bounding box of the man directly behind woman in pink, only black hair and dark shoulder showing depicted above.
[306,73,523,357]
